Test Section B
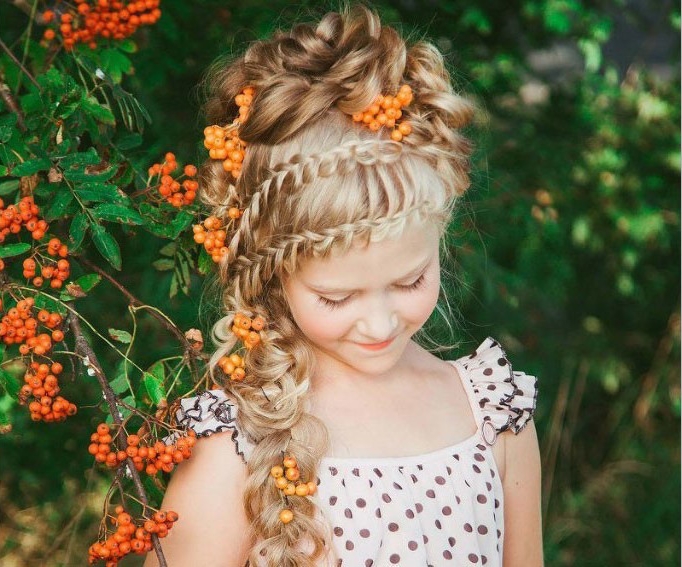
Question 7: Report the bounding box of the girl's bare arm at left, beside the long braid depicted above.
[144,432,250,567]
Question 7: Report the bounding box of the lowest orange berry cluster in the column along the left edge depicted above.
[19,361,78,423]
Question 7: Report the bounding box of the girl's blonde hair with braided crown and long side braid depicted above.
[201,7,473,567]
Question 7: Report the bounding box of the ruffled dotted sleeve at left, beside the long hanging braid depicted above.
[175,390,253,463]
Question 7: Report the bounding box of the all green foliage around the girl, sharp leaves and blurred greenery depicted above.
[0,0,680,566]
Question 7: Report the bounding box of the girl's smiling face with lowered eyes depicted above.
[284,222,440,375]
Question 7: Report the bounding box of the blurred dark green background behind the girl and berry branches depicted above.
[0,0,680,567]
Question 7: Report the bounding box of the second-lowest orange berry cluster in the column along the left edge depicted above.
[0,297,64,356]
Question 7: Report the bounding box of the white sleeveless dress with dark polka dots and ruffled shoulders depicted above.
[178,338,537,567]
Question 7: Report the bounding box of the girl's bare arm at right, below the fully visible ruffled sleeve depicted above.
[502,420,543,567]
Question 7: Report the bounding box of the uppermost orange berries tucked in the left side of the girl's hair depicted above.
[204,87,254,179]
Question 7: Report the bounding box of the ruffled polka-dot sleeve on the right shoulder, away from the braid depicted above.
[455,337,538,445]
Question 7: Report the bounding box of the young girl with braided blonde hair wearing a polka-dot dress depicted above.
[145,8,542,567]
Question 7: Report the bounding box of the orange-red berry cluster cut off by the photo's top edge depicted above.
[43,0,161,51]
